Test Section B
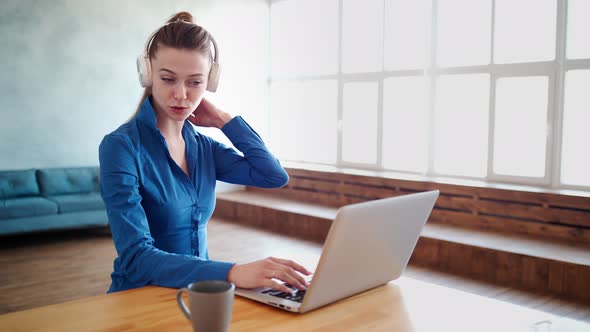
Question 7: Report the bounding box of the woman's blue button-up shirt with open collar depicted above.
[99,97,288,293]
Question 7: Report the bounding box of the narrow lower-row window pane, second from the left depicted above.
[342,82,378,164]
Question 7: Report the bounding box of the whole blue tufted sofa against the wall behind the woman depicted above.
[0,167,108,235]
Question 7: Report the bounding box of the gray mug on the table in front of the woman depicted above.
[176,280,236,332]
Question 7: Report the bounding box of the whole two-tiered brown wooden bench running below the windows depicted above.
[215,168,590,302]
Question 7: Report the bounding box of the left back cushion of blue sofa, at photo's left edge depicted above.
[0,169,39,199]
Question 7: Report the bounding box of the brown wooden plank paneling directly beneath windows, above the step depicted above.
[253,168,590,243]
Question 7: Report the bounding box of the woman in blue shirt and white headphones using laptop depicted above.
[99,12,310,293]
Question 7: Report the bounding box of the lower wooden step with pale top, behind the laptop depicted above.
[214,191,590,302]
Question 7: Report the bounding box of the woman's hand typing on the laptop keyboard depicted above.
[227,257,311,293]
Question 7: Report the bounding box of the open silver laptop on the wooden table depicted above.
[235,190,439,313]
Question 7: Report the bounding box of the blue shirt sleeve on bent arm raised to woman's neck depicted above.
[214,116,289,188]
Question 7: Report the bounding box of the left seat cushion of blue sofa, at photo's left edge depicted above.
[0,197,57,219]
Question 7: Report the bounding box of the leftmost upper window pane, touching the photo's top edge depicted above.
[270,0,338,75]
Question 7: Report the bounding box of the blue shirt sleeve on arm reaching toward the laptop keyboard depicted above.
[99,134,233,288]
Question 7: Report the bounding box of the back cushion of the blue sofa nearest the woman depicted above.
[37,167,98,196]
